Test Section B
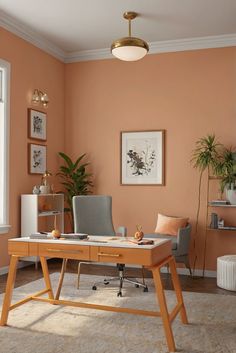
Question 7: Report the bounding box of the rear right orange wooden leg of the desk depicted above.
[169,257,188,324]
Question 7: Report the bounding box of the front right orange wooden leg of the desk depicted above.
[152,267,176,352]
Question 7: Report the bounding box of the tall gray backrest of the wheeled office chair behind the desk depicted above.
[72,195,116,236]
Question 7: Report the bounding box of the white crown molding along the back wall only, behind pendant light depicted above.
[65,34,236,63]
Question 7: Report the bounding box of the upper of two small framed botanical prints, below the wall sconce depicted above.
[28,108,47,141]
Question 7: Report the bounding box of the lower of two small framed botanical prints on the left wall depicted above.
[28,143,47,174]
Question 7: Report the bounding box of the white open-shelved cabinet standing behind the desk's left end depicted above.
[21,194,64,263]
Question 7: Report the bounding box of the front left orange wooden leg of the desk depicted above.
[0,255,19,326]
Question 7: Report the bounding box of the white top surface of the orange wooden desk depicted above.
[9,235,171,250]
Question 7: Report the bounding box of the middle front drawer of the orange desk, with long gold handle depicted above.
[39,243,89,260]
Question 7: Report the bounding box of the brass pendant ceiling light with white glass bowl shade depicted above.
[111,11,149,61]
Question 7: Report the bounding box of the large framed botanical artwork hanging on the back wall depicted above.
[121,130,165,185]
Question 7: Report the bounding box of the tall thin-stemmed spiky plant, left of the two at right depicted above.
[191,134,222,269]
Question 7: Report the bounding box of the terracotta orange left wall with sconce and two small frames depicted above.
[0,28,64,268]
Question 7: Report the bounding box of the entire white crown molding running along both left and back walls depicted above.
[0,11,236,63]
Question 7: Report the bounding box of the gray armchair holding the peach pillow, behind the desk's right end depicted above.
[145,223,192,276]
